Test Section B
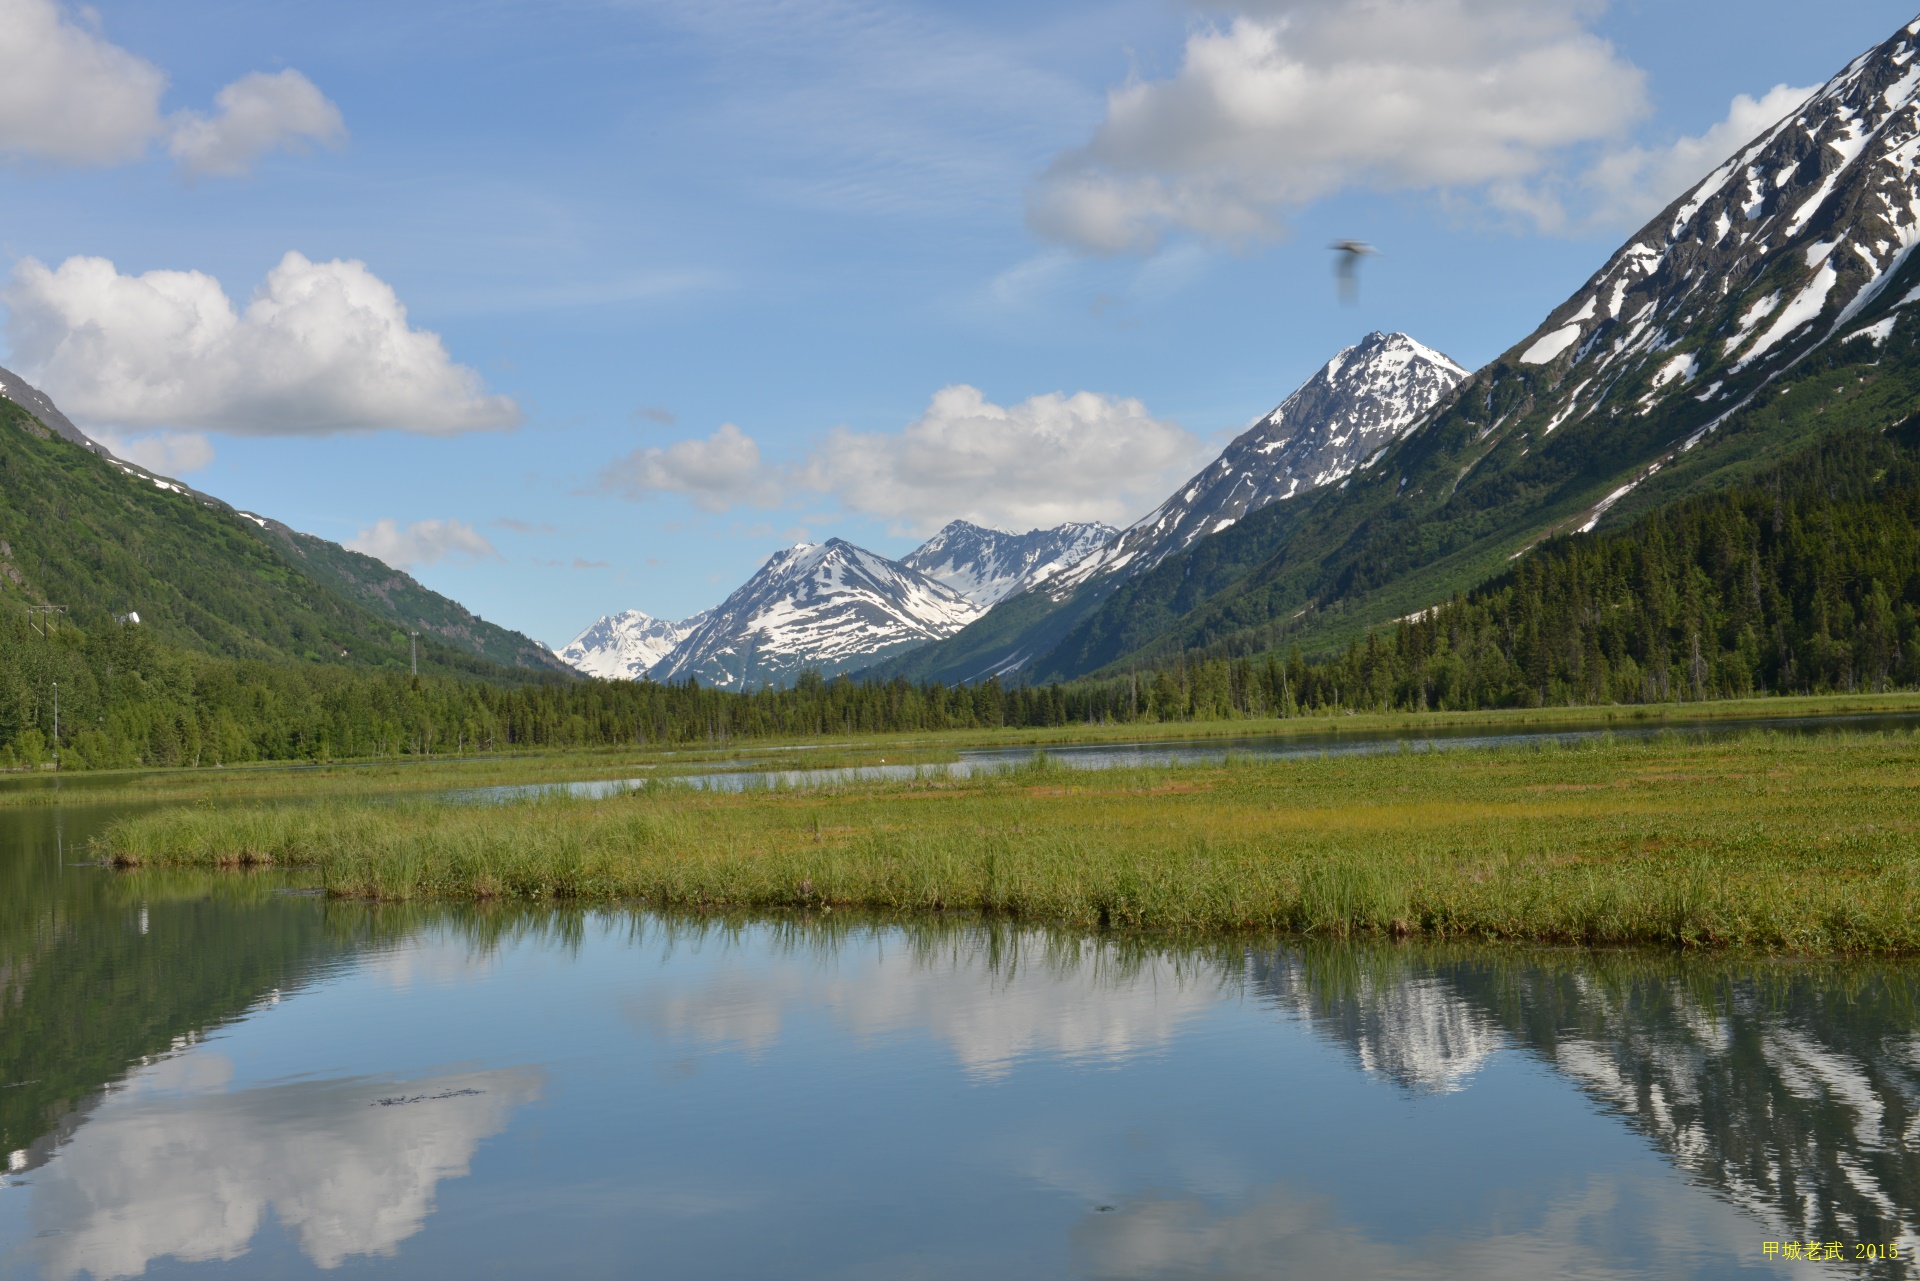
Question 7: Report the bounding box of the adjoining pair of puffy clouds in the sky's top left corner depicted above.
[0,0,346,175]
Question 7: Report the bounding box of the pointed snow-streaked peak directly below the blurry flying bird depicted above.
[1029,332,1467,599]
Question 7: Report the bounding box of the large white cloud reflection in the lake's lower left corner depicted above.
[33,1056,540,1279]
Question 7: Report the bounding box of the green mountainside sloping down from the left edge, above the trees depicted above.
[0,371,568,678]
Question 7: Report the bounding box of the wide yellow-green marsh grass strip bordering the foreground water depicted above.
[104,732,1920,955]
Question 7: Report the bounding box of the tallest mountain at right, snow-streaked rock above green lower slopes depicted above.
[879,12,1920,682]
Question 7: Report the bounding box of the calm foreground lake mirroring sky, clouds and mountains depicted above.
[0,787,1920,1279]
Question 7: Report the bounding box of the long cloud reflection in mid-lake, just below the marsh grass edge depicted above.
[626,933,1229,1079]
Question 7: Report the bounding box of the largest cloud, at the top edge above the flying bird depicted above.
[1027,0,1647,254]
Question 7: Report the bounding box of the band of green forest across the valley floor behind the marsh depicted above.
[0,430,1920,768]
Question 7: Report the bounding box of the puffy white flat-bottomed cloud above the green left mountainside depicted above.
[0,254,520,436]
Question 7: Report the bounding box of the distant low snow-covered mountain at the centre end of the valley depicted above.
[649,538,983,689]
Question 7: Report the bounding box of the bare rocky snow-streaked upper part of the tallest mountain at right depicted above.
[1461,21,1920,538]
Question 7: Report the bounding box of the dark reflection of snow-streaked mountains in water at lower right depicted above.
[1250,949,1920,1275]
